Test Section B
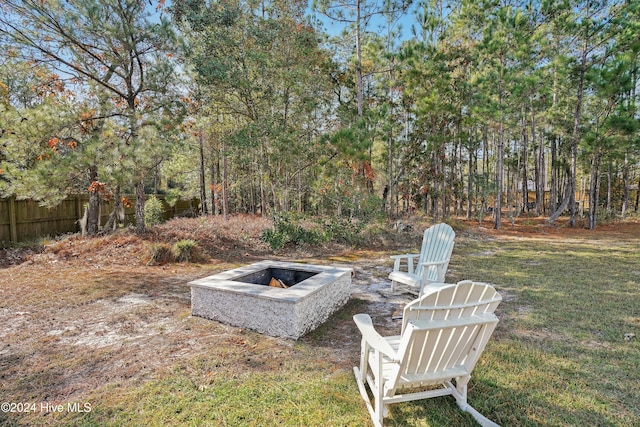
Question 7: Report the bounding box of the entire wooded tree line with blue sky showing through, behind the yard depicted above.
[0,0,640,233]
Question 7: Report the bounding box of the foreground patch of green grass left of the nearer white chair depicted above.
[63,369,367,426]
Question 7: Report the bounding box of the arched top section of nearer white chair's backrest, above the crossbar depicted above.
[402,280,502,332]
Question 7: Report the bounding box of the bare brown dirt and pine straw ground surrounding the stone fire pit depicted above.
[0,219,410,412]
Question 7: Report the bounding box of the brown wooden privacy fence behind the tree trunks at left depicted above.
[0,195,200,247]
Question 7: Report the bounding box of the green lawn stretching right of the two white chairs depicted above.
[444,236,640,426]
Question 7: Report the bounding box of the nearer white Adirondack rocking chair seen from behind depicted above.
[353,282,501,427]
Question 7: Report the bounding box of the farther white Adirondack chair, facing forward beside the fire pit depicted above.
[389,223,456,295]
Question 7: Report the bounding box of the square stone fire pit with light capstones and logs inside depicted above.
[189,261,352,339]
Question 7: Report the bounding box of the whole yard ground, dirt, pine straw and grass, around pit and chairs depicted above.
[0,217,640,426]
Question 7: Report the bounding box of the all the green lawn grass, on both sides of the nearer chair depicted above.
[0,229,640,427]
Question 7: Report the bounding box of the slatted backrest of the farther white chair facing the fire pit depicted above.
[415,223,456,282]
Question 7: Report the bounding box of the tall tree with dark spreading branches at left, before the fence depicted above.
[0,0,179,232]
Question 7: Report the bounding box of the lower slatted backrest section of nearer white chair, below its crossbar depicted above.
[385,313,498,396]
